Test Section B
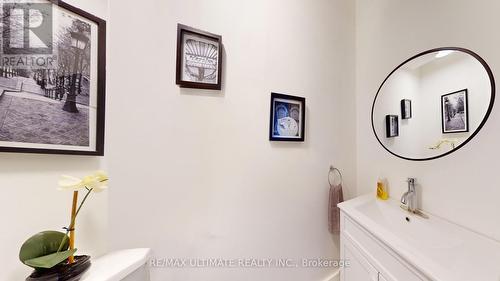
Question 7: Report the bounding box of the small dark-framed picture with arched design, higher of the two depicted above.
[175,24,222,90]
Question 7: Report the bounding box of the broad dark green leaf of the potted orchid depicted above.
[19,231,69,264]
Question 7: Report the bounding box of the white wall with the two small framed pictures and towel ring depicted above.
[107,0,356,281]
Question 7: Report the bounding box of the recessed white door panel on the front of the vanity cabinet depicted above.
[341,238,378,281]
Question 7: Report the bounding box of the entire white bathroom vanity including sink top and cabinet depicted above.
[338,194,500,281]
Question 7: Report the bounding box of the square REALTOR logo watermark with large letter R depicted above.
[0,0,56,69]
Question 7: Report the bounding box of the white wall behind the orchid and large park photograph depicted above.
[0,0,108,281]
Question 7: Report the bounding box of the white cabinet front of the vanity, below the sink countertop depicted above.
[340,213,430,281]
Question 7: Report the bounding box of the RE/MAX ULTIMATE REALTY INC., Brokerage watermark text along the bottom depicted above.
[149,258,350,268]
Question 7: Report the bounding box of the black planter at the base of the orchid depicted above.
[26,256,91,281]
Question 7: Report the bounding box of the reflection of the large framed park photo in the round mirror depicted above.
[441,89,469,134]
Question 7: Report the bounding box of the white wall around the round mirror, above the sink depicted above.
[356,0,500,240]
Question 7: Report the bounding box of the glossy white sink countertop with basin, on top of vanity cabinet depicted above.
[339,194,500,281]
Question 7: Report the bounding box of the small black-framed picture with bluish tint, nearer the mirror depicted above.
[269,93,306,142]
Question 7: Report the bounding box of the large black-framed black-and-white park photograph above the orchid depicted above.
[0,1,106,156]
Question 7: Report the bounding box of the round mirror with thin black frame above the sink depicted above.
[372,48,495,161]
